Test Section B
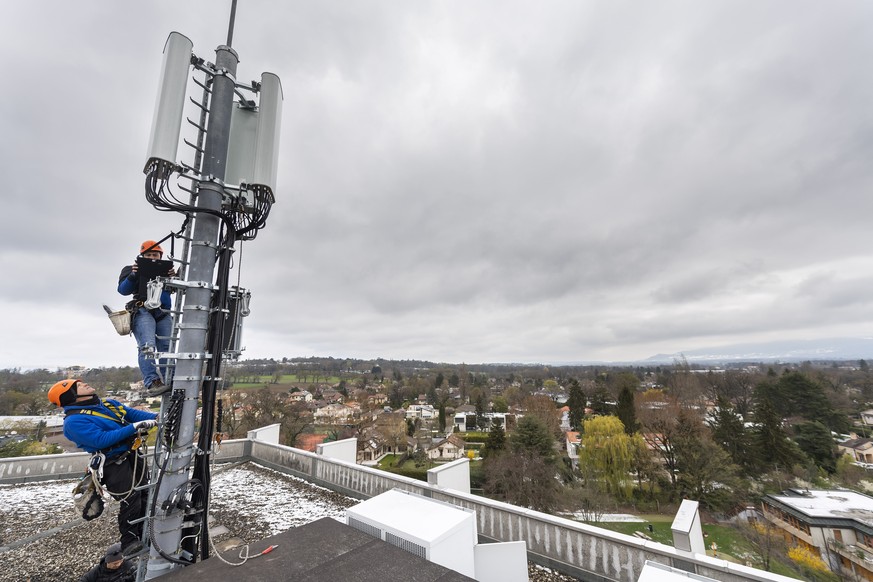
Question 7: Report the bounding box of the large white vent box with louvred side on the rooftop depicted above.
[346,489,478,578]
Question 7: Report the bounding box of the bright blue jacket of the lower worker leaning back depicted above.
[64,399,158,458]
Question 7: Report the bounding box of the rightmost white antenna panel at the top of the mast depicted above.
[252,73,283,200]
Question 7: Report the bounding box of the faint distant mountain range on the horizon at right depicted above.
[645,337,873,363]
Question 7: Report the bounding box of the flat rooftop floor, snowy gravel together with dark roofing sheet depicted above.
[0,462,573,582]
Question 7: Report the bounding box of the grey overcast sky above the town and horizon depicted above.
[0,0,873,367]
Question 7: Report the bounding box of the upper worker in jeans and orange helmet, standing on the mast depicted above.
[118,240,176,396]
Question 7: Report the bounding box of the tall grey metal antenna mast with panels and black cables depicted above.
[145,0,282,579]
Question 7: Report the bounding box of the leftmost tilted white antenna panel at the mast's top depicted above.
[146,32,194,169]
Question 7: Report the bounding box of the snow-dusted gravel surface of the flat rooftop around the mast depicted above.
[0,463,575,582]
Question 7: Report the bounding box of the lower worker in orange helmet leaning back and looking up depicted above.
[48,379,157,555]
